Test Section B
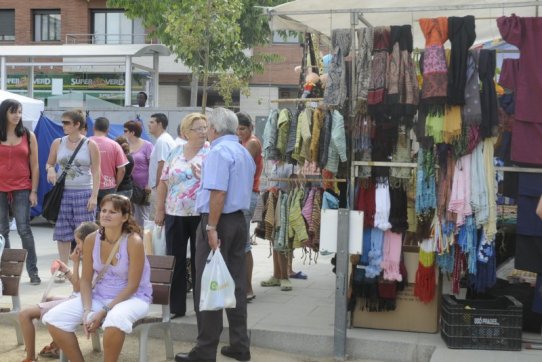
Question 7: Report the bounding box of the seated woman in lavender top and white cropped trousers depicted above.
[43,194,152,362]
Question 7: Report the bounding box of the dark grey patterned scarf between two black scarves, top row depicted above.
[463,50,482,126]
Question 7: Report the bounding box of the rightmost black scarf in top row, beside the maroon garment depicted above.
[478,49,499,139]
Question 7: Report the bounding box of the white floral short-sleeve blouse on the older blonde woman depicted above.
[160,142,211,216]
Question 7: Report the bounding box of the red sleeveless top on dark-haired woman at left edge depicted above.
[0,132,32,192]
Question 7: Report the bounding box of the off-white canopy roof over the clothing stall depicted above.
[268,0,542,48]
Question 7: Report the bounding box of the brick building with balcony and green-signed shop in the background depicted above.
[0,0,302,117]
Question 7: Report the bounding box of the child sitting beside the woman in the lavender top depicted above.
[19,222,99,362]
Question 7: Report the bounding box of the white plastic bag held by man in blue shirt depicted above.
[199,249,236,311]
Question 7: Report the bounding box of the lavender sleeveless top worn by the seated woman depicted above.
[92,233,152,303]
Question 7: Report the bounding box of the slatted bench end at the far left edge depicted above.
[0,249,27,345]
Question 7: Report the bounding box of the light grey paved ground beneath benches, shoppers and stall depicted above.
[0,219,542,362]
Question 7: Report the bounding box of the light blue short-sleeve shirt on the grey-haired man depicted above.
[196,135,256,214]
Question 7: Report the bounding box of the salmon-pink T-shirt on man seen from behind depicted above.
[90,136,128,190]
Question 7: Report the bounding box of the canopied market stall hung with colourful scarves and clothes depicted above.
[264,1,542,357]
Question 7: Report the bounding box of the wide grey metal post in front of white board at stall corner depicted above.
[333,209,350,361]
